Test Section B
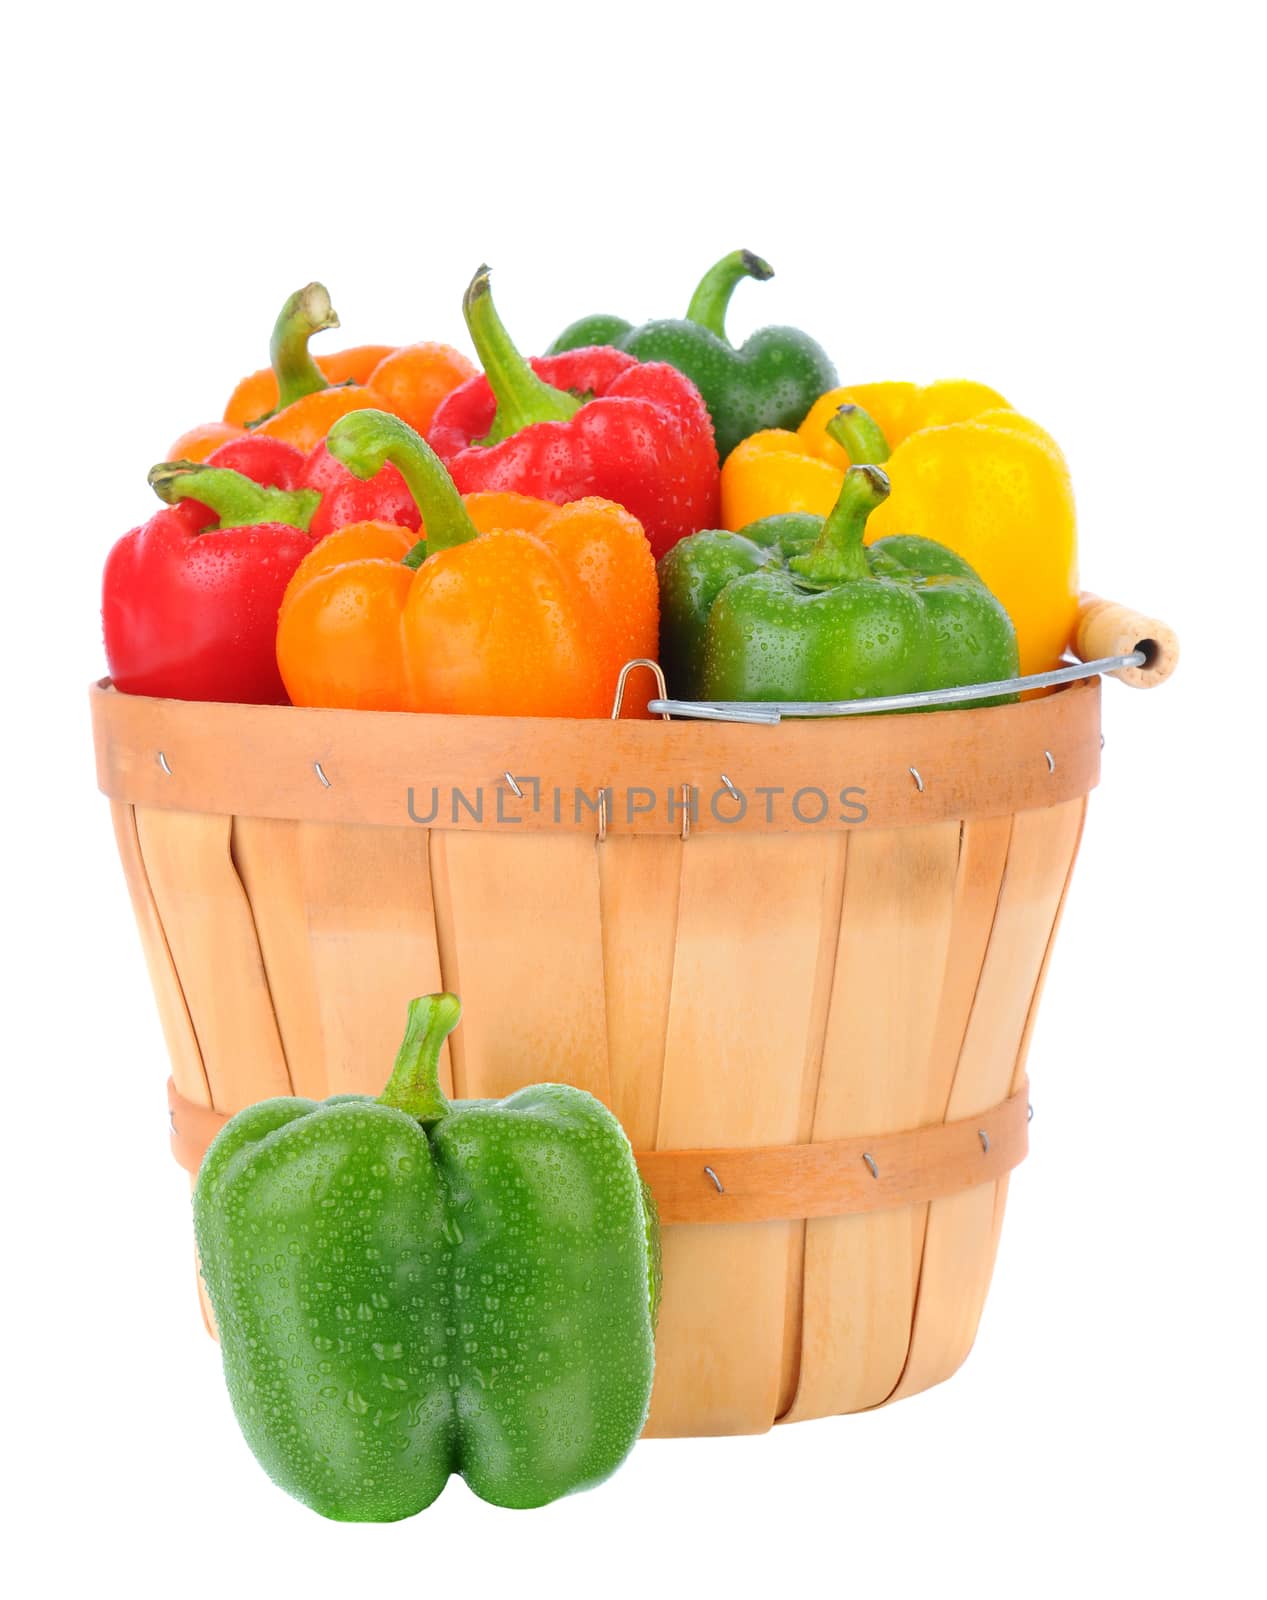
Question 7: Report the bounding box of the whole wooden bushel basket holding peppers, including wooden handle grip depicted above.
[91,605,1169,1435]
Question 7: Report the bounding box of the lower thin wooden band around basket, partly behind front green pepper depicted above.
[168,1078,1029,1224]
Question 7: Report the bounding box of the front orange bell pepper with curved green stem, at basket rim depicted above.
[277,411,659,717]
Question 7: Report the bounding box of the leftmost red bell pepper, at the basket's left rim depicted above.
[101,466,320,704]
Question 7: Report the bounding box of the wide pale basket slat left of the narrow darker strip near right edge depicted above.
[785,822,960,1421]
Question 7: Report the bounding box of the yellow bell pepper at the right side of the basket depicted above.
[721,379,1078,672]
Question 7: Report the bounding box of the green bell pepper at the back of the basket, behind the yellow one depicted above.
[547,250,837,461]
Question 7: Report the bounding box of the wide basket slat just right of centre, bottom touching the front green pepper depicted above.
[646,837,840,1435]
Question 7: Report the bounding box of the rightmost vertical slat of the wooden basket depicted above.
[891,798,1086,1400]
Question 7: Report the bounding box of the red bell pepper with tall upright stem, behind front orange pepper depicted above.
[427,267,720,557]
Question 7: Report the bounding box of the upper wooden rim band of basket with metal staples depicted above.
[90,680,1099,838]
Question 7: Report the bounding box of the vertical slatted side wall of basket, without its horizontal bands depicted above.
[115,798,1086,1435]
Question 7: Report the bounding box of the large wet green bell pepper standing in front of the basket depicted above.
[194,994,659,1522]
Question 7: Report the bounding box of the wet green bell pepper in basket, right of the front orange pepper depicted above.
[659,408,1017,706]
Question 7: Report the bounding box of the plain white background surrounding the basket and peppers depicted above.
[0,0,1267,1600]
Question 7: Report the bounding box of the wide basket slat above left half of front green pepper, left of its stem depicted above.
[234,818,453,1099]
